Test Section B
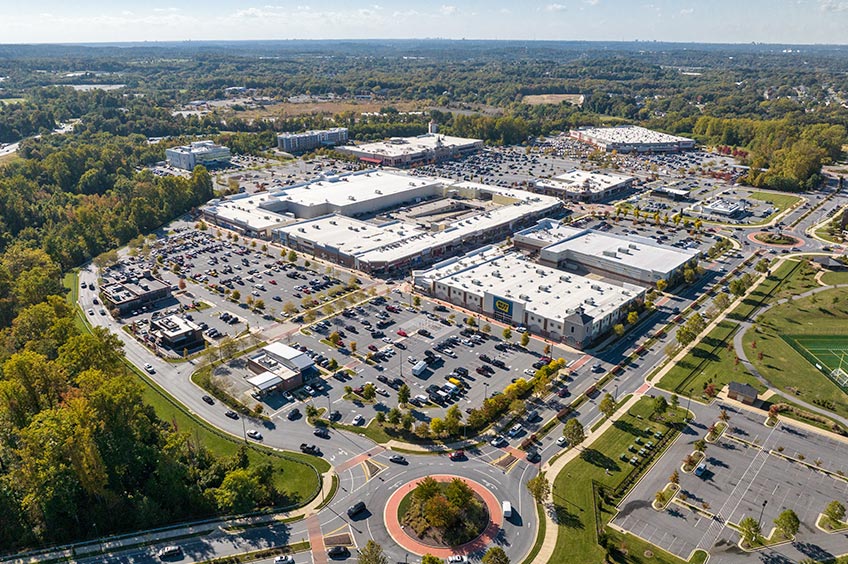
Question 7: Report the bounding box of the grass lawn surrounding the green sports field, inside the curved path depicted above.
[743,288,848,416]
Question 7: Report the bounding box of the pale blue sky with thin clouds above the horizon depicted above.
[0,0,848,44]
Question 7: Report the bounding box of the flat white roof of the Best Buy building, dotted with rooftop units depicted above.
[416,247,641,322]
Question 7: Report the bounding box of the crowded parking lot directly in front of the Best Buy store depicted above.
[248,293,582,442]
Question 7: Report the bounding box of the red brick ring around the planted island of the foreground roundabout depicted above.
[383,474,503,558]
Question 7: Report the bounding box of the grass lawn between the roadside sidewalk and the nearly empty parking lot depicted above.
[552,398,703,564]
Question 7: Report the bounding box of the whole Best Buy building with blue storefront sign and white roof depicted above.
[413,246,645,349]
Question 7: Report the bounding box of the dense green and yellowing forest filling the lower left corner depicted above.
[0,247,292,551]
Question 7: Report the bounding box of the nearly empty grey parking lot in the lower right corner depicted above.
[613,408,848,560]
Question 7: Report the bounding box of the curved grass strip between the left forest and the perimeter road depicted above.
[63,272,330,505]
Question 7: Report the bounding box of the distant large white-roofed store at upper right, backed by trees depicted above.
[569,125,695,153]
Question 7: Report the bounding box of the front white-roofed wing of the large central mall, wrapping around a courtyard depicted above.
[274,182,562,275]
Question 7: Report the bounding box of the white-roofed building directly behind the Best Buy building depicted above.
[513,219,699,286]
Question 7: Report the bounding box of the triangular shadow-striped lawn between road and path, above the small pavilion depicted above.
[657,320,765,398]
